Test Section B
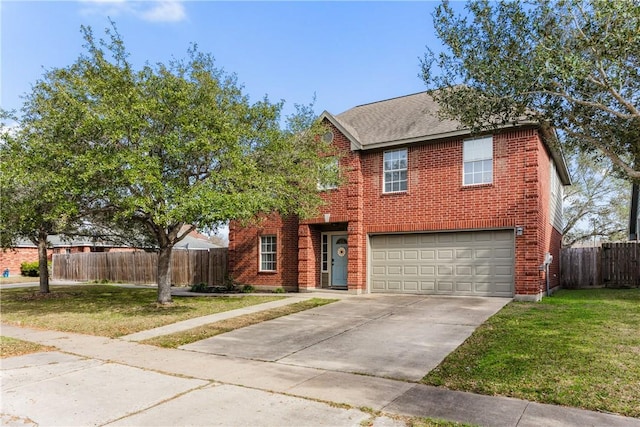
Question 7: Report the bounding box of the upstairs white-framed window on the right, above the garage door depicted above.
[462,136,493,185]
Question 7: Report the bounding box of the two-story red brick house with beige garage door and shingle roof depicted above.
[229,92,570,300]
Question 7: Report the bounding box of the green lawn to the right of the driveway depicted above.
[422,289,640,417]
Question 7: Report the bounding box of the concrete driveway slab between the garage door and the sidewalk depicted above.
[181,295,510,381]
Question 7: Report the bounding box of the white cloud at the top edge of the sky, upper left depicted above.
[80,0,187,22]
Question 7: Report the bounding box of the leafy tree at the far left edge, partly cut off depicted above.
[0,71,100,293]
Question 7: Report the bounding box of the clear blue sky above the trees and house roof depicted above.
[0,0,450,120]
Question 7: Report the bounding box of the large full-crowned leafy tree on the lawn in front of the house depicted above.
[26,26,333,304]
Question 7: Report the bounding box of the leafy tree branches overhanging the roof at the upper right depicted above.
[422,0,640,181]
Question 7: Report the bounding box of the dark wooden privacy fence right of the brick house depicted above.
[560,242,640,289]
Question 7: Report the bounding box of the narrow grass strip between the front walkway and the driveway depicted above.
[142,298,338,348]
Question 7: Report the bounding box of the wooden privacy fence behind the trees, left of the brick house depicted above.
[52,248,227,286]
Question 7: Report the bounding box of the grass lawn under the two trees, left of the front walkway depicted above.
[0,285,284,338]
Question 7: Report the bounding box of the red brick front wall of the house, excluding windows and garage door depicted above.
[229,124,560,295]
